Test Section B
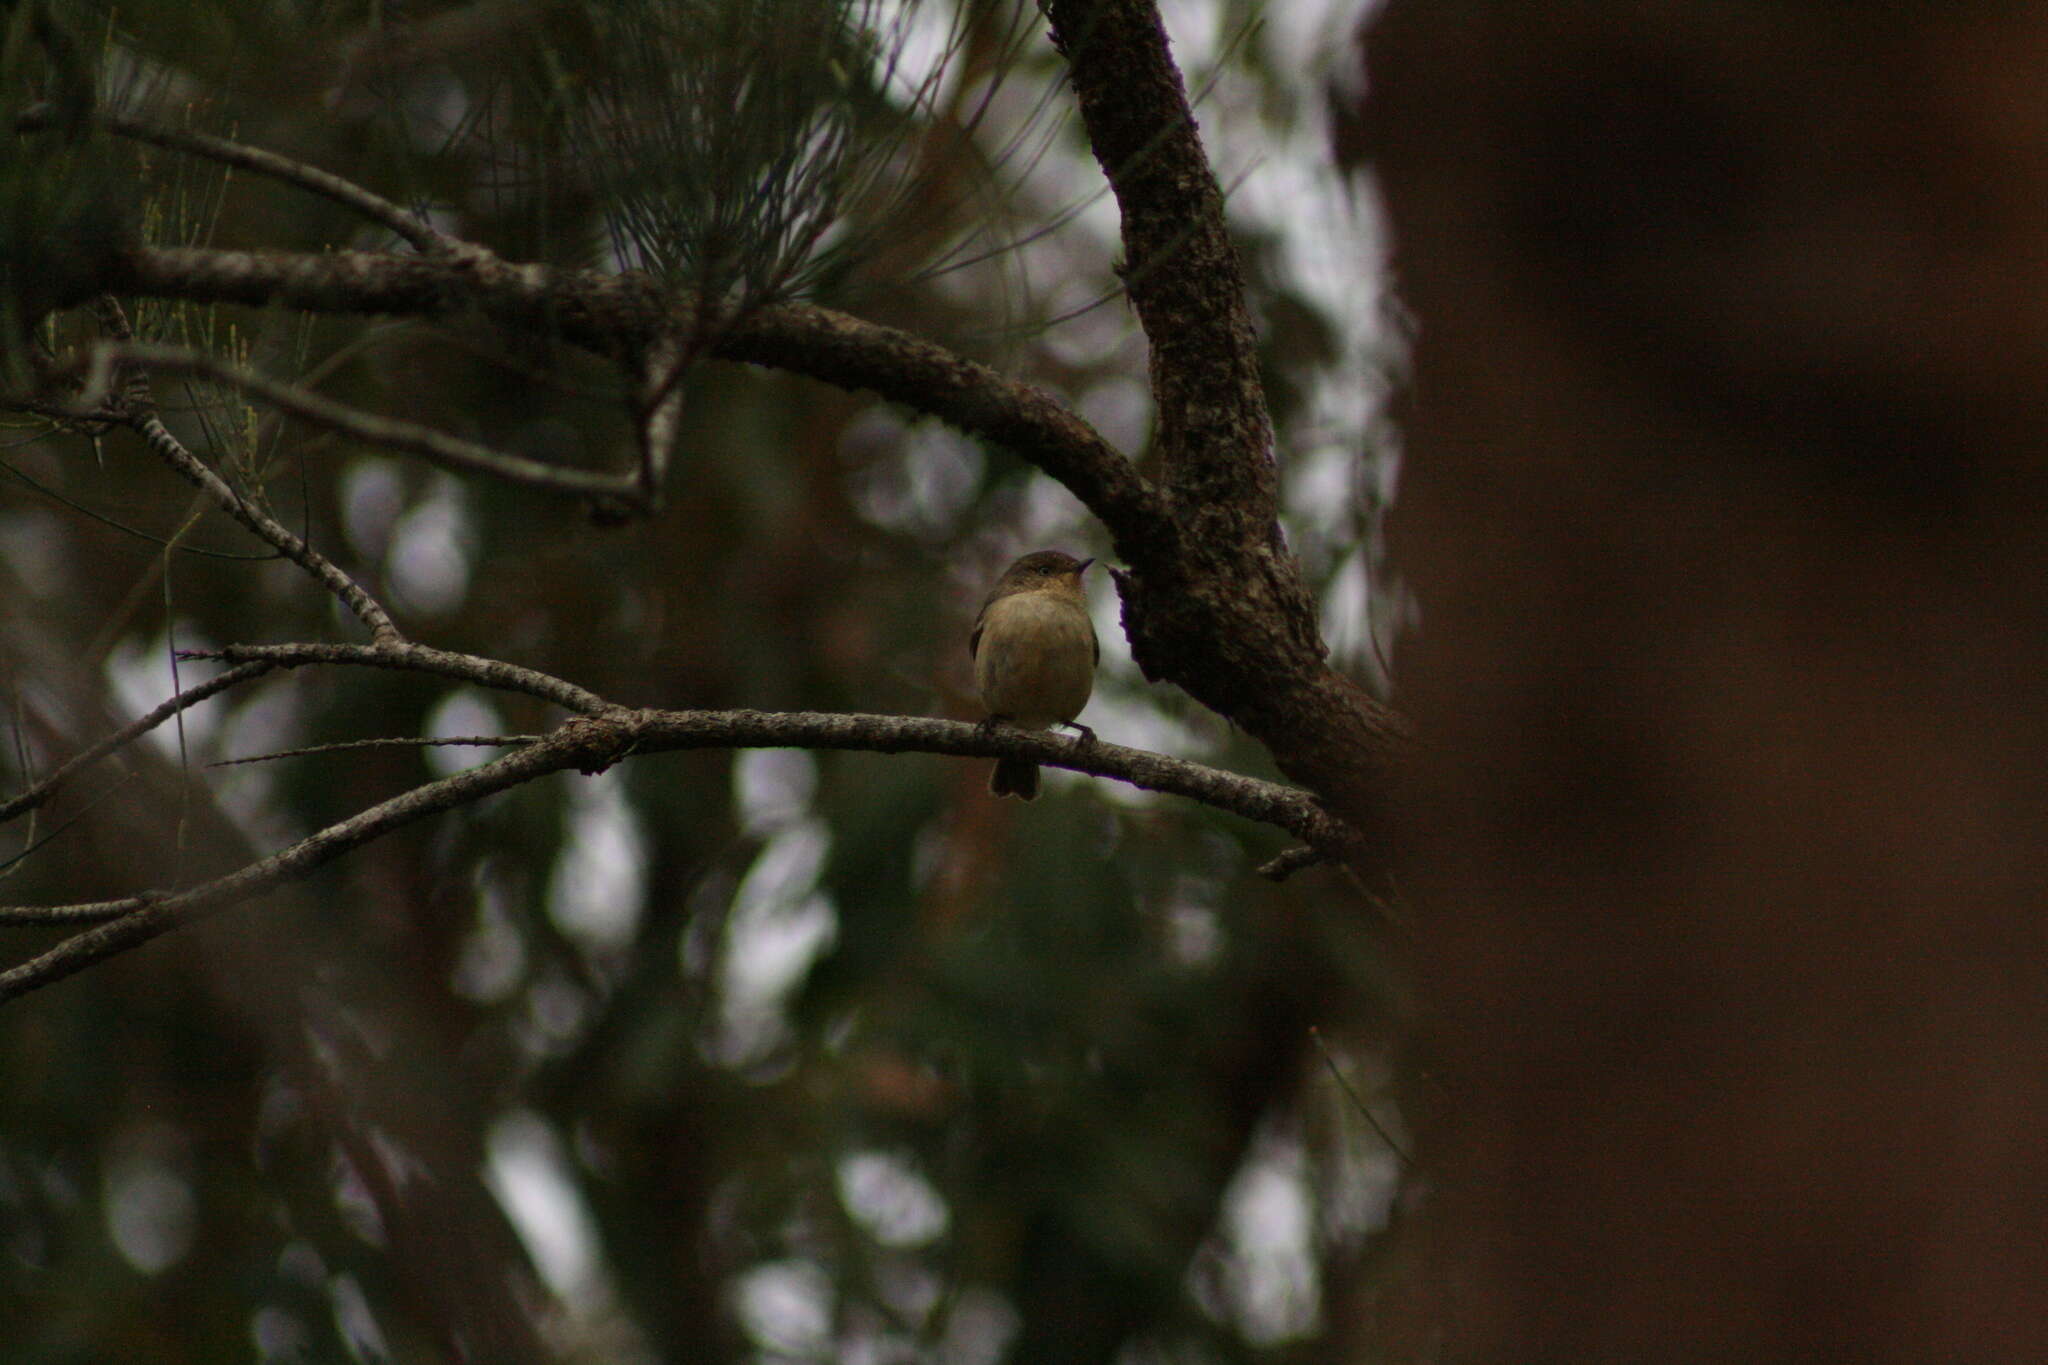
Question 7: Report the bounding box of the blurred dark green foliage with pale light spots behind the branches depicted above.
[0,0,1411,1365]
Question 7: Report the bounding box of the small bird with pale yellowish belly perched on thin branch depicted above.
[967,551,1102,800]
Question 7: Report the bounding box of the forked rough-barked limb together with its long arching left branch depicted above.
[36,0,1401,843]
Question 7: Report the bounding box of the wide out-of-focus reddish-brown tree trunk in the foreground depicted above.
[1354,0,2048,1365]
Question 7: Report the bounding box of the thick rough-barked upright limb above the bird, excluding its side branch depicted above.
[1044,0,1403,827]
